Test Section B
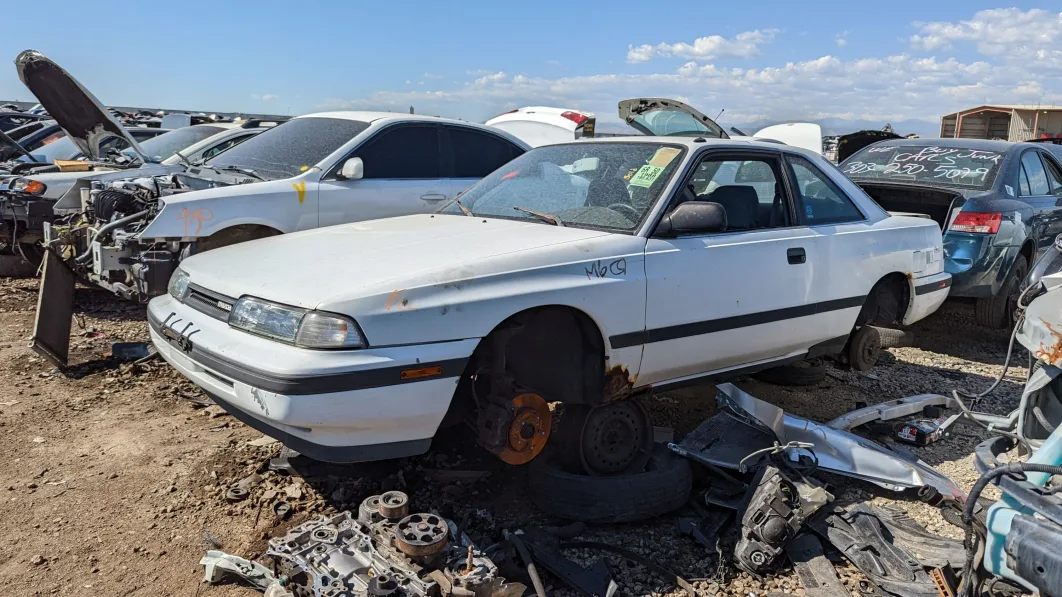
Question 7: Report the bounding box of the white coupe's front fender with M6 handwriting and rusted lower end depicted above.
[318,235,646,375]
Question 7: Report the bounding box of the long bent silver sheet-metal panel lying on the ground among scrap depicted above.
[718,383,966,501]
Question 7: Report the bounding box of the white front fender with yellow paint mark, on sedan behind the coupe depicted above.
[139,176,318,242]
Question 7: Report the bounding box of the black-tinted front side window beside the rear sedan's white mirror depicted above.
[354,125,441,178]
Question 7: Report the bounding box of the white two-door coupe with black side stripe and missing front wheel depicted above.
[148,137,950,465]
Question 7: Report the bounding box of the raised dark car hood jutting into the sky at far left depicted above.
[15,50,147,161]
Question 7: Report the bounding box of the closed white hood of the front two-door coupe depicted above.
[181,215,615,309]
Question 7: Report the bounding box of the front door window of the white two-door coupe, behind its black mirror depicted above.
[683,155,790,232]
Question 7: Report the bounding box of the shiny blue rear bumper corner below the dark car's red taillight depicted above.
[944,233,1021,297]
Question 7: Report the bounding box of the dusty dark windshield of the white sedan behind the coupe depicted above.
[207,117,369,180]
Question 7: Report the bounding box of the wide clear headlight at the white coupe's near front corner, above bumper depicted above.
[228,296,365,348]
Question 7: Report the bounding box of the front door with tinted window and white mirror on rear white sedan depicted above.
[319,123,453,226]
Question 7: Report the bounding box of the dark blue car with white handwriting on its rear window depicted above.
[841,139,1062,327]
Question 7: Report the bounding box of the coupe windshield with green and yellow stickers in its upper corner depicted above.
[440,142,685,232]
